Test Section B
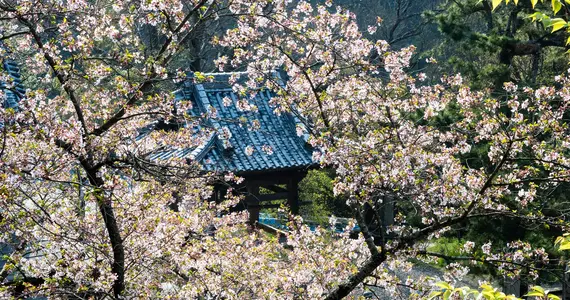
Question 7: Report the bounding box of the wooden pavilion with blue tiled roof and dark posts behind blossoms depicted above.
[144,73,317,224]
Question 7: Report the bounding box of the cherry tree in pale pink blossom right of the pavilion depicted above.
[216,3,568,299]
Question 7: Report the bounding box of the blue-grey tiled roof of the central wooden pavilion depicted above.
[146,73,314,173]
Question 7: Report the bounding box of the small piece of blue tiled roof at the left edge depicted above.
[0,59,25,108]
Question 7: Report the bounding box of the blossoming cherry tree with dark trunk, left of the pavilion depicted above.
[0,0,362,298]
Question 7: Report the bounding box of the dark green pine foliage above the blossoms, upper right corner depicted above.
[424,0,567,90]
